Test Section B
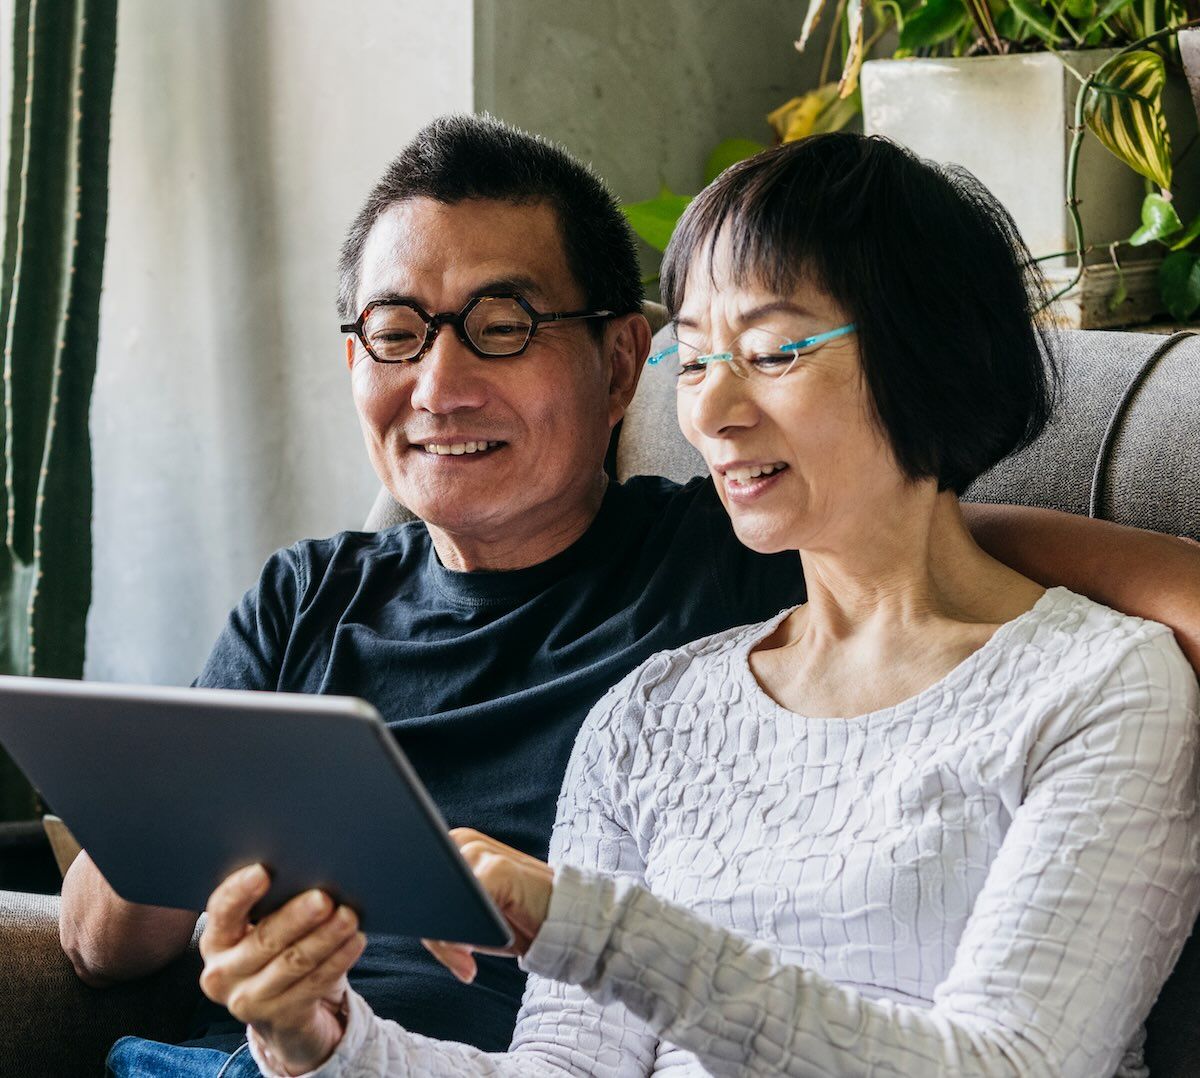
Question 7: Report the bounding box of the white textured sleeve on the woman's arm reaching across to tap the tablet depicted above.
[523,634,1200,1078]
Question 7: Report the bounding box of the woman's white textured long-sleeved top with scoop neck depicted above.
[256,588,1200,1078]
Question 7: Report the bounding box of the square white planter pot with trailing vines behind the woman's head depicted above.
[862,49,1200,327]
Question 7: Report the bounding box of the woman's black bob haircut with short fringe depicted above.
[662,133,1058,495]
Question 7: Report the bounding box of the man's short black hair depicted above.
[337,115,642,333]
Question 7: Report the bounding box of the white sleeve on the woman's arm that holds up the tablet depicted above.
[243,678,659,1078]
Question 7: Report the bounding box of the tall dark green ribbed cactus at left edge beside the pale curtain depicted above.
[0,0,116,820]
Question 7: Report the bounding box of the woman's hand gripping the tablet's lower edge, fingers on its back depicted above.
[200,864,366,1074]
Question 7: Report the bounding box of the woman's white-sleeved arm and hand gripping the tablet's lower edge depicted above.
[214,683,658,1078]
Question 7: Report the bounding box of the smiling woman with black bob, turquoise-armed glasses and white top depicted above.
[209,134,1200,1078]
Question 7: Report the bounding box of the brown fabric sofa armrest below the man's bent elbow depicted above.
[0,891,200,1074]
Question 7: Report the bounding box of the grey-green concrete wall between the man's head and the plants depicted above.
[475,0,829,285]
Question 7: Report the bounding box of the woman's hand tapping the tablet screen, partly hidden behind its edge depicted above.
[421,827,554,984]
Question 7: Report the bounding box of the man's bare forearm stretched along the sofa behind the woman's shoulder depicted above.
[962,502,1200,671]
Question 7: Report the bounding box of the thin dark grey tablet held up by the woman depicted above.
[0,677,511,947]
